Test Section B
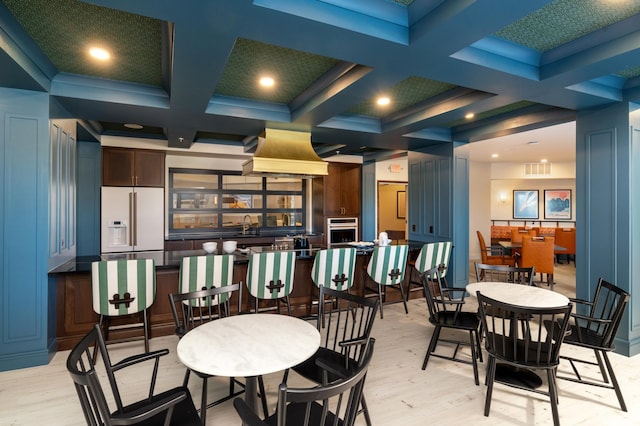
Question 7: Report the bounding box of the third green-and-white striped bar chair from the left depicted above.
[247,251,296,315]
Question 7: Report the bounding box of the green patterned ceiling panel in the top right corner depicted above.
[494,0,640,52]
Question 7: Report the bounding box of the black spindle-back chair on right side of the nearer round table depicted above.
[283,286,379,425]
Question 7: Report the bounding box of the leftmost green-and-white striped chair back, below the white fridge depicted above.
[91,259,156,316]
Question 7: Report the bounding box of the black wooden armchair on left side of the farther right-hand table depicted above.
[421,267,482,385]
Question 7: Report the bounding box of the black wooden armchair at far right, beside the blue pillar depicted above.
[558,278,630,411]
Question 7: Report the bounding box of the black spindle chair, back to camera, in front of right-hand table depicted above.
[477,293,573,425]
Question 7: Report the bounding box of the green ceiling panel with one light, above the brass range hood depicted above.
[215,38,338,104]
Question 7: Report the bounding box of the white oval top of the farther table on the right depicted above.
[467,281,569,308]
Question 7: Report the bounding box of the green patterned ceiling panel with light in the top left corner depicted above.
[2,0,162,86]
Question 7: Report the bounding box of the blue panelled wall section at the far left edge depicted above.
[0,88,55,371]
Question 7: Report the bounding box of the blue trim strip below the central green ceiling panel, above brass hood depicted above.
[206,95,291,123]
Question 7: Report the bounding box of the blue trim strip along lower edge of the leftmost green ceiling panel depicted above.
[51,73,169,109]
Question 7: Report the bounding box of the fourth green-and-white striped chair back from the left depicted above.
[311,247,356,291]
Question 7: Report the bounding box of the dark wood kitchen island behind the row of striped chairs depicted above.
[49,243,422,350]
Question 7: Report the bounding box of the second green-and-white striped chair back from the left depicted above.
[180,254,234,306]
